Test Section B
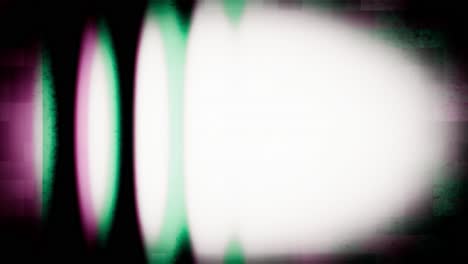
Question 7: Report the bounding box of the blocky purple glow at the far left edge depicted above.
[0,48,41,219]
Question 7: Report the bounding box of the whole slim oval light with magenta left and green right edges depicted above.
[75,20,120,245]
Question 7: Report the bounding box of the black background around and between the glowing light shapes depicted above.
[0,0,468,263]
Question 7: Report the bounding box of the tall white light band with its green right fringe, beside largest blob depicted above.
[134,1,188,263]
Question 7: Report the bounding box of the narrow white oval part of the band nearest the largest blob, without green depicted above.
[134,16,169,246]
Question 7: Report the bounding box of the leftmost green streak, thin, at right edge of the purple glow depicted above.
[39,50,57,219]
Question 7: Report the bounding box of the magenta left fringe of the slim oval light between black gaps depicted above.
[75,24,98,241]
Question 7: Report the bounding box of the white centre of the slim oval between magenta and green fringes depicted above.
[87,43,115,223]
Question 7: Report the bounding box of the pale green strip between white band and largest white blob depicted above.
[146,1,189,263]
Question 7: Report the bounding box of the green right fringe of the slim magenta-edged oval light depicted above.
[94,21,121,244]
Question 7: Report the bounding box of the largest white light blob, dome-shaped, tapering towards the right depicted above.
[185,4,451,258]
